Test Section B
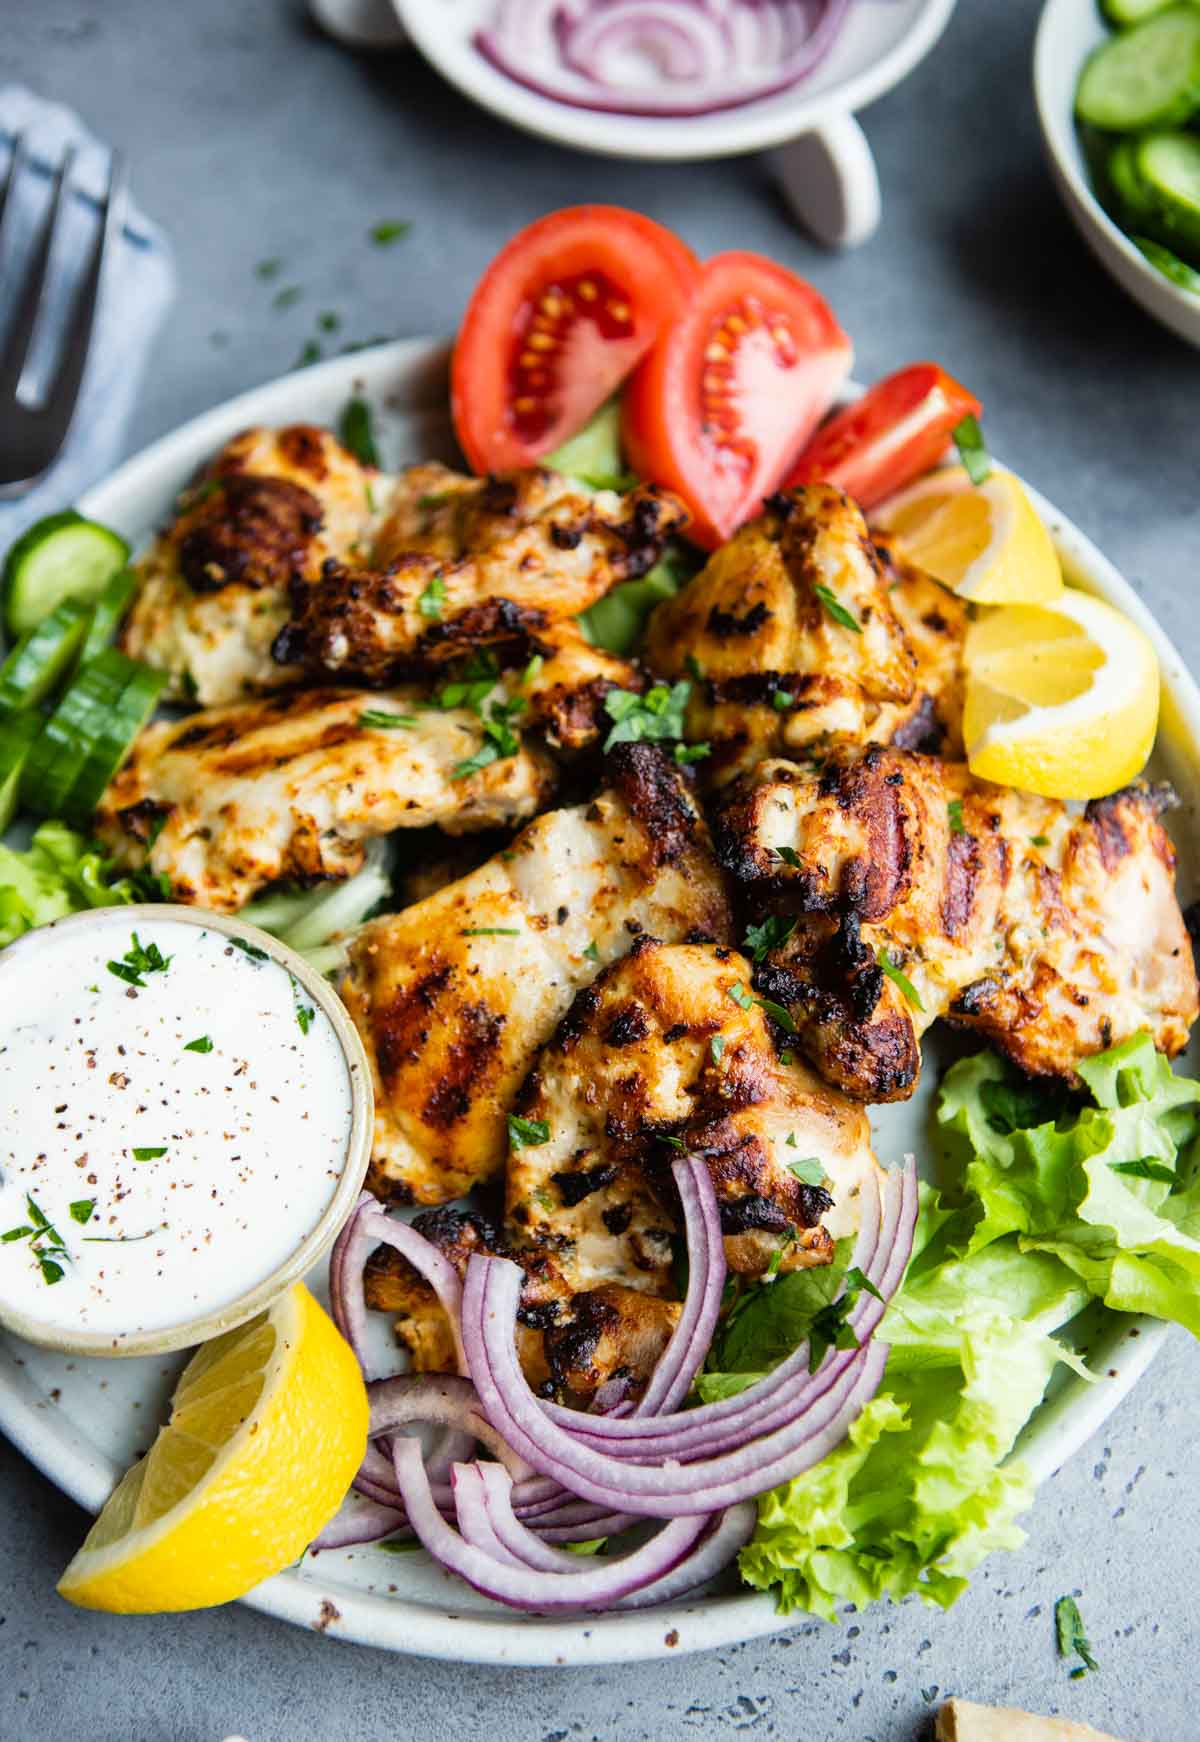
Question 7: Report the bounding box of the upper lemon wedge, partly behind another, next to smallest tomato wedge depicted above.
[873,465,1062,604]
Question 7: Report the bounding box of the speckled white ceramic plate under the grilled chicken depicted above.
[0,340,1200,1664]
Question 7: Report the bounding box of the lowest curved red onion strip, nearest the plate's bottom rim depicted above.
[395,1439,707,1613]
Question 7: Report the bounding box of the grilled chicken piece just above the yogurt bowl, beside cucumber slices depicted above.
[96,688,554,913]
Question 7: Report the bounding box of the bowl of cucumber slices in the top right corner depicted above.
[1033,0,1200,345]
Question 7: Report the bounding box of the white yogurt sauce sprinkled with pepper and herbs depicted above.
[0,909,352,1347]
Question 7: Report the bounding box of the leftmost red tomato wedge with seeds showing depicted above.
[451,206,700,472]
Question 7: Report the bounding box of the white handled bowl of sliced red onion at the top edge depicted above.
[388,0,954,246]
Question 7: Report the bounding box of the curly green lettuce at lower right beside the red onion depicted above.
[734,1035,1200,1620]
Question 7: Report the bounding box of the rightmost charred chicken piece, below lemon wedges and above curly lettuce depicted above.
[714,746,1197,1101]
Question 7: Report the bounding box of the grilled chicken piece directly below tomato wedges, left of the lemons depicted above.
[644,484,965,786]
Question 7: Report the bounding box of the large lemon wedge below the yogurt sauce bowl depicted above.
[57,1284,367,1615]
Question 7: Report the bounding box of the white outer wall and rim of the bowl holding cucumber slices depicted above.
[1033,0,1200,345]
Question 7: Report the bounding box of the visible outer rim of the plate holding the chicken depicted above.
[0,338,1200,1667]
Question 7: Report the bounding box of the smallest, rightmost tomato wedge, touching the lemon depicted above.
[787,362,982,509]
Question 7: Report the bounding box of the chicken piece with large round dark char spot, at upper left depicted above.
[120,423,381,707]
